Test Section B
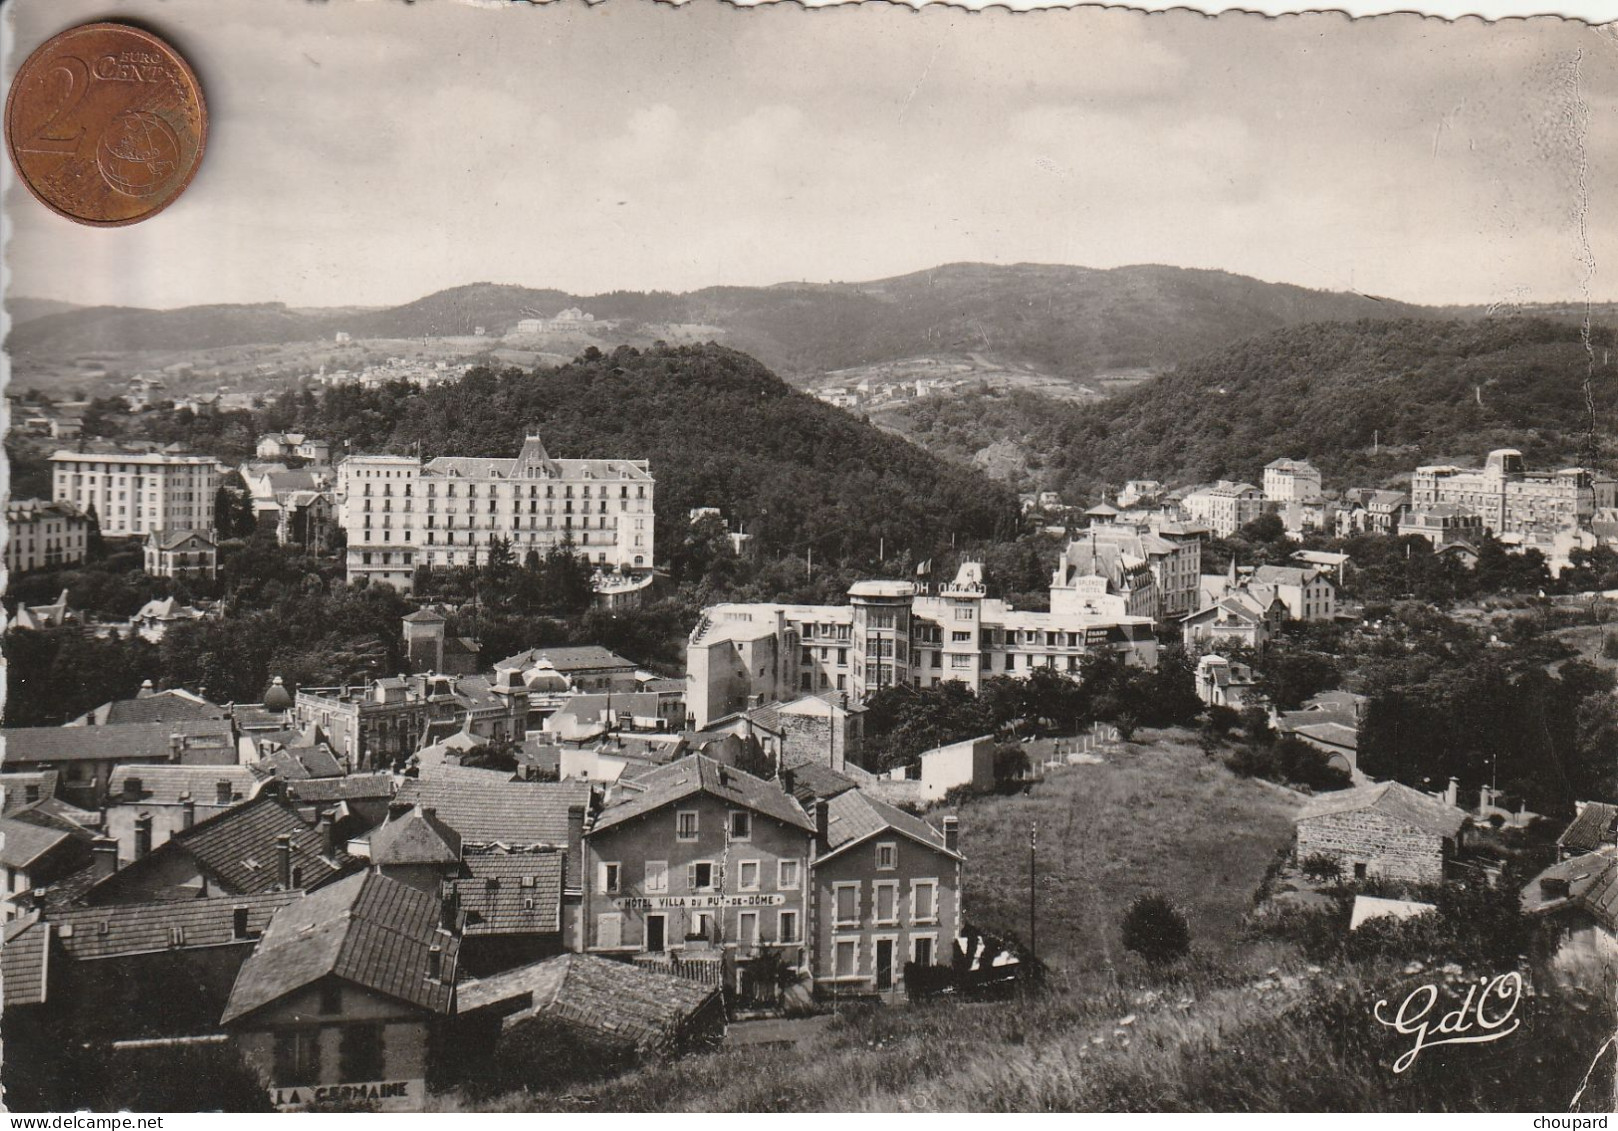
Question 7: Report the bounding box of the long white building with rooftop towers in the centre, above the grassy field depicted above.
[686,561,1157,730]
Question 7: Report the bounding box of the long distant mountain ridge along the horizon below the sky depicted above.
[6,264,1449,380]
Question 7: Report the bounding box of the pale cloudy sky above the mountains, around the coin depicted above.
[3,0,1618,307]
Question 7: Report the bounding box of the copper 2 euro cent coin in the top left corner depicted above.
[5,23,207,227]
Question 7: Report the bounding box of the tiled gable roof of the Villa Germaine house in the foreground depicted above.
[223,872,460,1023]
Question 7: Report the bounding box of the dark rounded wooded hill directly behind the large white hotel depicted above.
[254,345,1016,565]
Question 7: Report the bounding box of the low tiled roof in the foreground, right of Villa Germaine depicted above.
[461,955,720,1050]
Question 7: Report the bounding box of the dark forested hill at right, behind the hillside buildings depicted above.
[893,317,1618,498]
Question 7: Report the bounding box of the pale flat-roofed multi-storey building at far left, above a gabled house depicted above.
[50,450,220,537]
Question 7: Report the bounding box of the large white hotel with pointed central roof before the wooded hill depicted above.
[337,435,654,592]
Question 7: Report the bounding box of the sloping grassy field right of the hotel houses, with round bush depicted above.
[959,730,1299,981]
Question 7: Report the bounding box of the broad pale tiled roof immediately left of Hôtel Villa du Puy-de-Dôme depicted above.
[395,775,591,888]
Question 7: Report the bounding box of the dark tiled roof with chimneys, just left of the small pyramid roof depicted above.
[167,793,361,892]
